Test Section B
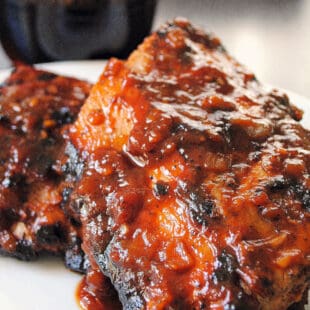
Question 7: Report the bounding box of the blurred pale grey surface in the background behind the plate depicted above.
[0,0,310,98]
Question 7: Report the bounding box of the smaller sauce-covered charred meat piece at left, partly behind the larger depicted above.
[0,65,91,270]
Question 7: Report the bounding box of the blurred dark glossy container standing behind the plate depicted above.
[0,0,156,63]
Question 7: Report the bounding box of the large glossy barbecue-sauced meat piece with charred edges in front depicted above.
[70,20,310,309]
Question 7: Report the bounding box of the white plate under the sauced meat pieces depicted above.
[0,61,310,310]
